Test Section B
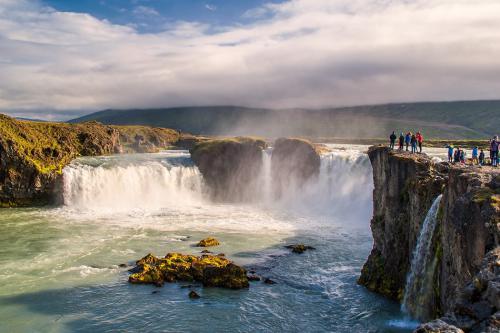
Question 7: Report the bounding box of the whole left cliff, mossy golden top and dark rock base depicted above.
[0,114,179,207]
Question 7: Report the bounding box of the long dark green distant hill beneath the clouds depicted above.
[71,101,500,139]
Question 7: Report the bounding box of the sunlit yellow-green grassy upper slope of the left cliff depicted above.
[0,114,179,173]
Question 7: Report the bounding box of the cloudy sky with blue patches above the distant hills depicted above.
[0,0,500,120]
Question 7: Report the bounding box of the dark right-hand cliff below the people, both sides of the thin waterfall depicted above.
[358,147,500,330]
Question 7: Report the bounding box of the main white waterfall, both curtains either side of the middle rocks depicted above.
[63,149,373,223]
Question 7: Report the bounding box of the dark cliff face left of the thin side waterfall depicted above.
[358,147,447,300]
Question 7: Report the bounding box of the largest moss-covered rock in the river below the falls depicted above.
[129,253,249,289]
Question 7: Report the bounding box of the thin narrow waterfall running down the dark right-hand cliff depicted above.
[402,195,442,319]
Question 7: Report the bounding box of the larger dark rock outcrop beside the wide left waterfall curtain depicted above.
[190,137,266,201]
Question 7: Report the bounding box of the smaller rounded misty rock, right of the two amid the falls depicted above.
[271,138,321,197]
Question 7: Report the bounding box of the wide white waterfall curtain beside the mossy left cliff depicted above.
[63,154,203,212]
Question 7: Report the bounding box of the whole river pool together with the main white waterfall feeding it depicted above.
[0,145,417,332]
